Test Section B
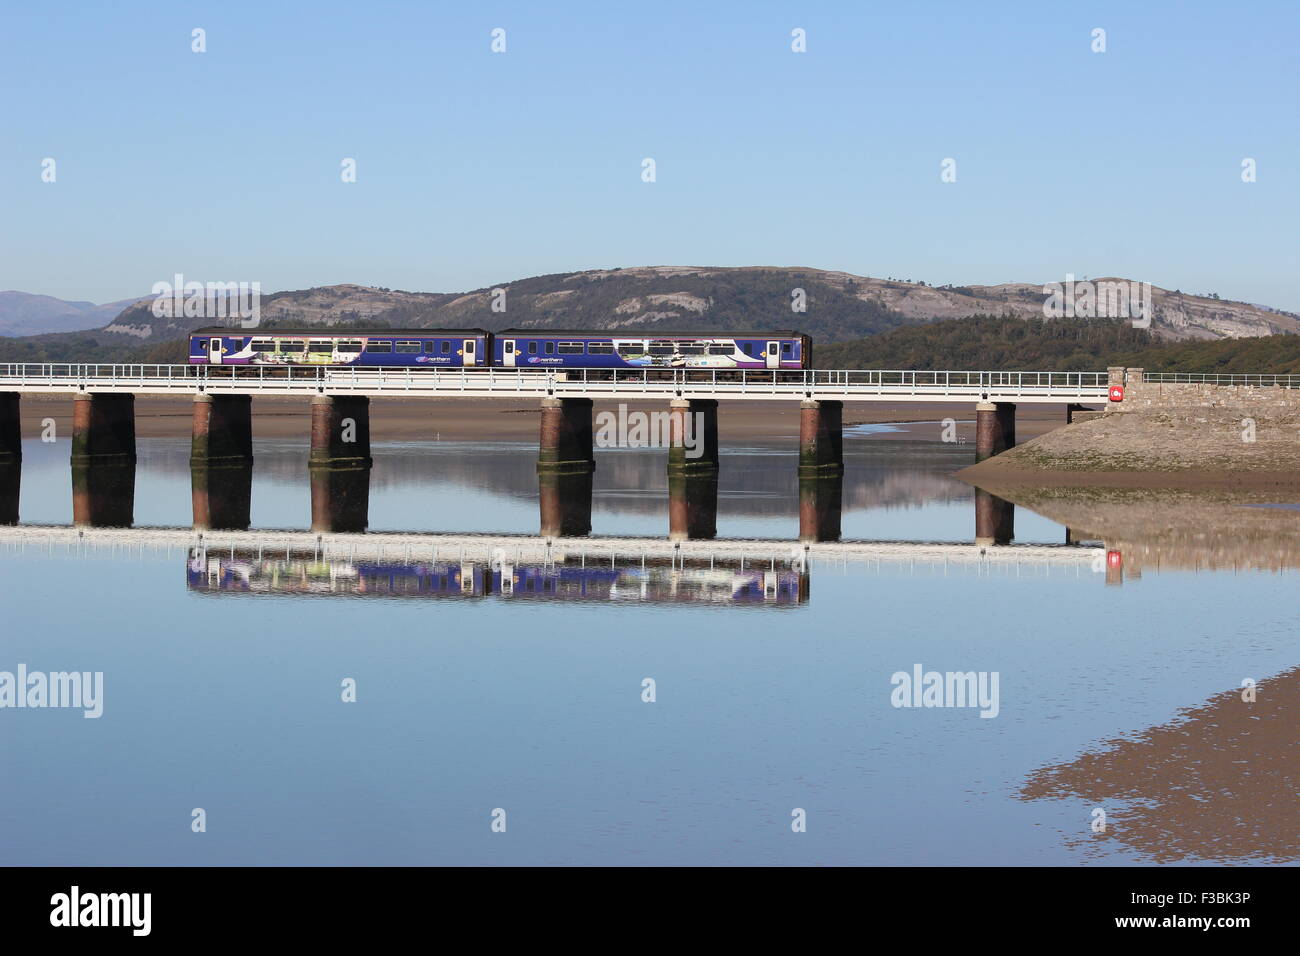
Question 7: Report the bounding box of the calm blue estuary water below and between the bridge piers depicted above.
[0,434,1300,865]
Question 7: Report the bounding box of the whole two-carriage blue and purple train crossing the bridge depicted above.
[190,326,813,369]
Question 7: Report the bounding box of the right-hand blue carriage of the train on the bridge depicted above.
[493,329,813,371]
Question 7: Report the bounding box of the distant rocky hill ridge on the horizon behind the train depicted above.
[3,265,1300,360]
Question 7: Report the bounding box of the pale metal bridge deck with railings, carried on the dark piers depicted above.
[0,363,1109,403]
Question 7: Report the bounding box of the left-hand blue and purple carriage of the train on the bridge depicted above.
[190,326,491,368]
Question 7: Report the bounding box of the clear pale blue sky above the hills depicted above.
[0,0,1300,311]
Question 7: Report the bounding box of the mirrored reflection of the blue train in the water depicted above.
[186,549,809,606]
